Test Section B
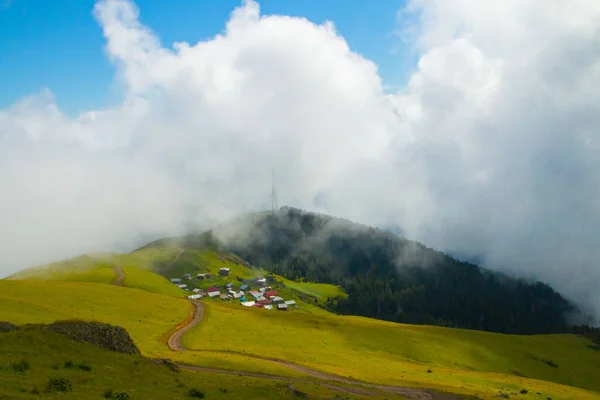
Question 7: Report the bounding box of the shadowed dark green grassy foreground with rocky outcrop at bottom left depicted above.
[0,328,383,400]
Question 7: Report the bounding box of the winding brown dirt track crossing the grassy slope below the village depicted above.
[167,300,459,400]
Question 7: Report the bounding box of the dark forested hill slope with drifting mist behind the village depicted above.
[144,207,575,334]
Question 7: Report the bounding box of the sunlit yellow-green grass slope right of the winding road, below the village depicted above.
[184,302,600,399]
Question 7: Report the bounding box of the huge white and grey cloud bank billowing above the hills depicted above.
[0,0,600,314]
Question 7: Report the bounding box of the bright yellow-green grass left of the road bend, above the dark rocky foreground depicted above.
[0,280,190,356]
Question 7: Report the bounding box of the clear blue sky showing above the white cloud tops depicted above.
[0,0,414,115]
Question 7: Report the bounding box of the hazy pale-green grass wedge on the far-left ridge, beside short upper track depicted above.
[6,253,116,283]
